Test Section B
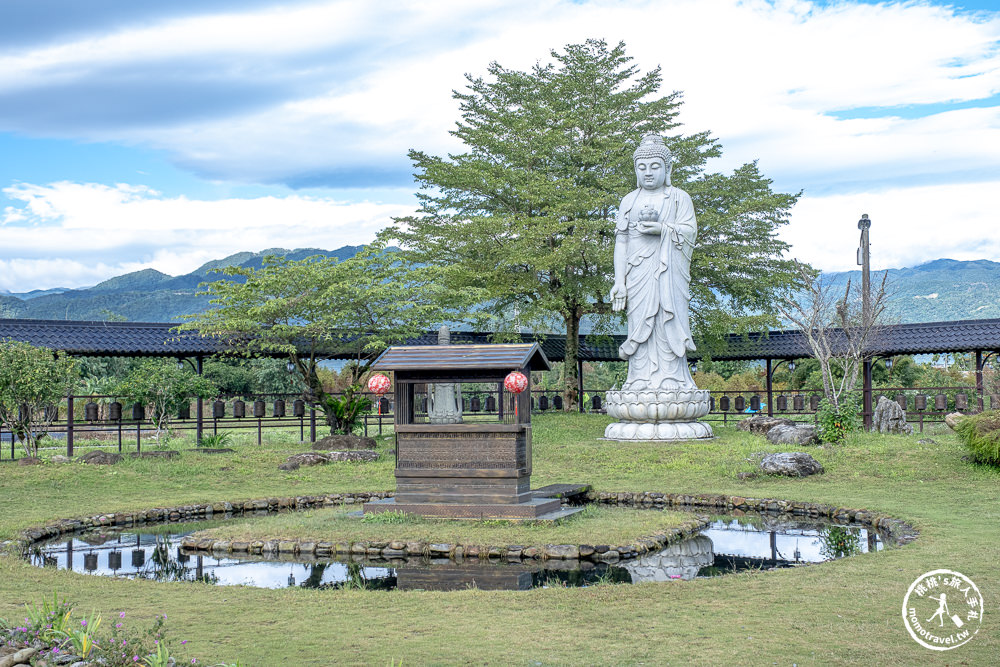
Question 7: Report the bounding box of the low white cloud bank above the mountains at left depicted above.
[0,182,413,292]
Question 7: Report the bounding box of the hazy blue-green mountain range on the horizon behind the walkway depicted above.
[0,246,1000,324]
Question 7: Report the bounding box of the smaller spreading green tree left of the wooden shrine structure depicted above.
[180,244,481,433]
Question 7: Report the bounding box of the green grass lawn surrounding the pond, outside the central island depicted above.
[0,414,1000,665]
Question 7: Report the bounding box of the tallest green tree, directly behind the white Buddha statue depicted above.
[387,40,796,409]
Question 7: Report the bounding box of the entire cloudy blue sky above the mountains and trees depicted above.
[0,0,1000,292]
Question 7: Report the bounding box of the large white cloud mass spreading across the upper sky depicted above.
[0,0,1000,189]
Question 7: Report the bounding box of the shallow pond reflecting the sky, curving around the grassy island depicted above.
[28,510,885,590]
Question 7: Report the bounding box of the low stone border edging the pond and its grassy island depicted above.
[0,491,919,563]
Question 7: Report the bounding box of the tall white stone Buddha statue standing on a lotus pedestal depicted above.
[605,134,712,440]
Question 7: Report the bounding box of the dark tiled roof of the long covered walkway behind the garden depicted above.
[0,319,1000,361]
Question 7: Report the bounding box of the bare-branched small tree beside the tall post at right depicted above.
[778,263,889,409]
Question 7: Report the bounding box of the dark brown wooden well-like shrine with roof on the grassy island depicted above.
[364,343,560,519]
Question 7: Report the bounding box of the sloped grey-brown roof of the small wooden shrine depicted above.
[372,343,552,371]
